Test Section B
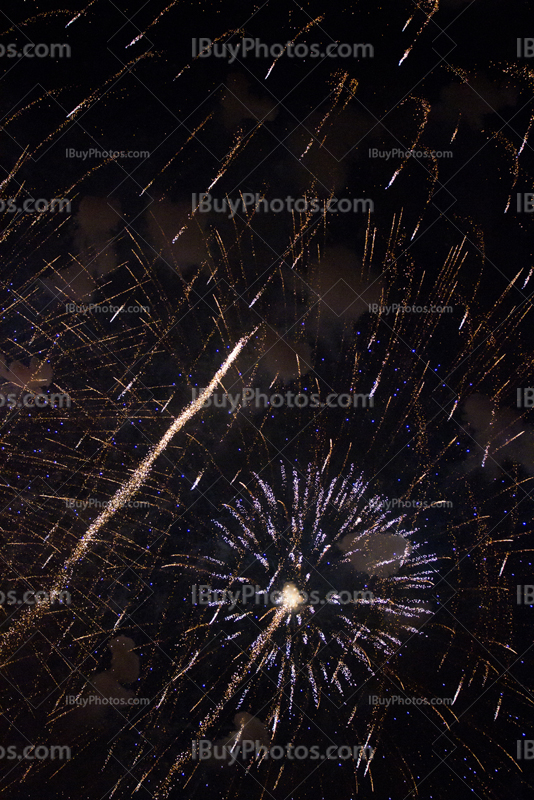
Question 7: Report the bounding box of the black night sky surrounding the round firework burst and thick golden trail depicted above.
[0,0,534,800]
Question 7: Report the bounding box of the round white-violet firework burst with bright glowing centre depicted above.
[158,464,436,780]
